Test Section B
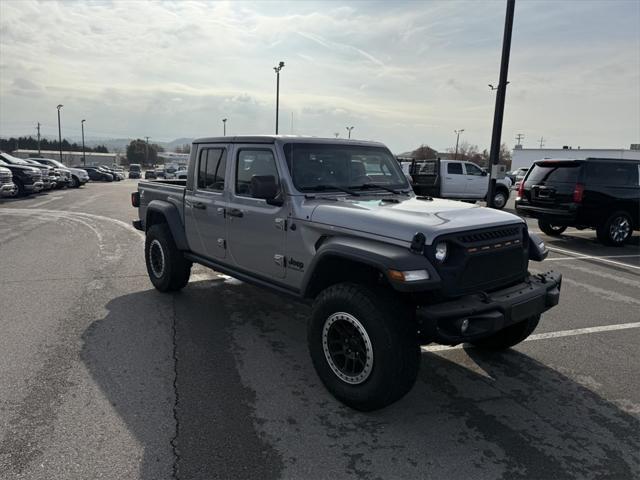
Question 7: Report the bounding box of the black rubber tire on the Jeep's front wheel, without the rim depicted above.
[307,283,420,411]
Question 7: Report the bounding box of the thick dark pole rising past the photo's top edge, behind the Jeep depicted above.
[487,0,516,207]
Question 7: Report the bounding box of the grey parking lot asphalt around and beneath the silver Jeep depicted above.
[0,180,640,479]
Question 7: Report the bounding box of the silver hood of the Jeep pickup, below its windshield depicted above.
[307,197,523,244]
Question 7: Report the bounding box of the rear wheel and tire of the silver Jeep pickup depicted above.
[144,223,191,292]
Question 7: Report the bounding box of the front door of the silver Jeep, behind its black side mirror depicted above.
[226,145,287,278]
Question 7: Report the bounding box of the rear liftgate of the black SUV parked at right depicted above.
[524,160,584,209]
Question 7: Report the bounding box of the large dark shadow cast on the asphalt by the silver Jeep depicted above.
[82,279,640,479]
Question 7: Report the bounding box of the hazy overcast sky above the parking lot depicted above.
[0,0,640,152]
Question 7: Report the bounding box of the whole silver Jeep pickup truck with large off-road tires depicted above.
[131,136,562,411]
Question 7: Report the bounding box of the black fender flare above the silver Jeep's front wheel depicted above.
[300,237,440,297]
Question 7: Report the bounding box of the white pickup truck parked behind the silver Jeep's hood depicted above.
[409,159,511,209]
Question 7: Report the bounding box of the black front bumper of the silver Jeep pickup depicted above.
[416,272,562,345]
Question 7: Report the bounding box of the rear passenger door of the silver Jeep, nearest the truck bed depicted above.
[184,144,229,259]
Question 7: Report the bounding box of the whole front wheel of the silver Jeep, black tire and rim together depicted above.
[307,283,420,411]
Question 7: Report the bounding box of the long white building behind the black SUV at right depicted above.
[511,145,640,170]
